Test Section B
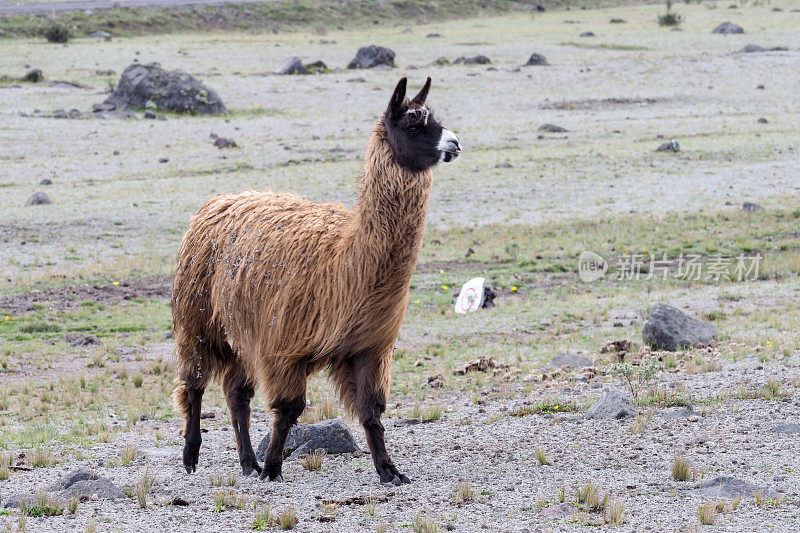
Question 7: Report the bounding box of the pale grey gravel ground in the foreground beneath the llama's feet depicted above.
[0,348,800,531]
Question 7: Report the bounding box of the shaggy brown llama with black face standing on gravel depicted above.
[172,78,461,485]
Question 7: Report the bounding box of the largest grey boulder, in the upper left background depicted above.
[103,63,227,115]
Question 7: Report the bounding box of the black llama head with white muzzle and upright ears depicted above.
[383,78,461,171]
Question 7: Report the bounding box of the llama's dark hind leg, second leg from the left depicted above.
[223,364,261,476]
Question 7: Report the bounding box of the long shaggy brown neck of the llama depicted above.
[348,122,433,284]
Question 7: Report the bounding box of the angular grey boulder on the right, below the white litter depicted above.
[642,303,717,351]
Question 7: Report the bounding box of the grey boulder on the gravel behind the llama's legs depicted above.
[256,418,359,461]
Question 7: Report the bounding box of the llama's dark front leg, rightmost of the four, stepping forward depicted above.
[351,356,411,485]
